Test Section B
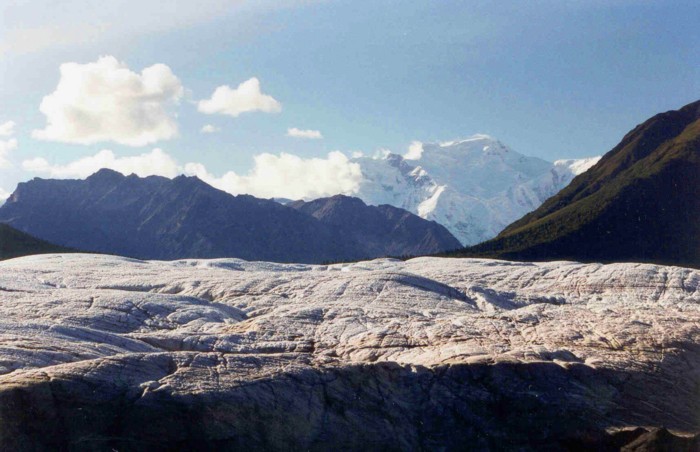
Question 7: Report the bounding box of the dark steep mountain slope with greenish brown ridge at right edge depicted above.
[465,101,700,267]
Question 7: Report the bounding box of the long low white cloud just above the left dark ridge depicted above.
[22,148,181,179]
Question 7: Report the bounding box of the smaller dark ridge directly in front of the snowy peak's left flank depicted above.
[287,195,461,256]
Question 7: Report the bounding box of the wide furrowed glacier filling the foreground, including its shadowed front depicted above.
[0,254,700,450]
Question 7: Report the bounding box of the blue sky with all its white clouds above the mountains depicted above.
[0,0,700,198]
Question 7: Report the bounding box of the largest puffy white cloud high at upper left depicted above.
[32,56,184,146]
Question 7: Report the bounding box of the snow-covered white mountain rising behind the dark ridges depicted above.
[354,135,599,245]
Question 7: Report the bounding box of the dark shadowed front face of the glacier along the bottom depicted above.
[0,344,700,451]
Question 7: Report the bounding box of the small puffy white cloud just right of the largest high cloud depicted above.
[197,77,282,118]
